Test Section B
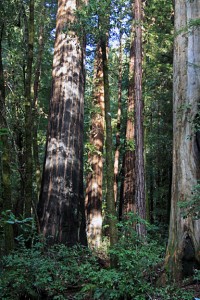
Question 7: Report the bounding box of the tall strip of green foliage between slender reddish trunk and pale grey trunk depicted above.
[143,0,174,227]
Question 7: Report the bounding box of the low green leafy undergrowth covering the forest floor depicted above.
[0,222,195,300]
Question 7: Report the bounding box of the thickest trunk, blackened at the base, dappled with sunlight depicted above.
[38,0,86,245]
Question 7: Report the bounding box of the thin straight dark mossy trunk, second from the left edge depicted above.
[24,0,34,217]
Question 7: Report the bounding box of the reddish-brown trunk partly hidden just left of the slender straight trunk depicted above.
[122,13,135,215]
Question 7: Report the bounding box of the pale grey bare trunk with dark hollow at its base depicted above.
[166,0,200,281]
